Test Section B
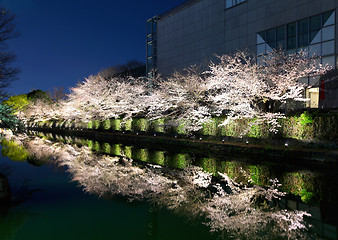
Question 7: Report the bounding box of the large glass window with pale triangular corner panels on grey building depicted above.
[257,11,336,67]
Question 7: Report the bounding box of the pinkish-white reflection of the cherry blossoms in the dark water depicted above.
[10,133,311,239]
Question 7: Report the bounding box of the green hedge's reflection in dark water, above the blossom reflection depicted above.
[32,132,338,205]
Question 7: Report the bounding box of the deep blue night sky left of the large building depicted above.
[0,0,185,94]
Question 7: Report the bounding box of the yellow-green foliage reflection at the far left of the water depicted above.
[1,139,29,162]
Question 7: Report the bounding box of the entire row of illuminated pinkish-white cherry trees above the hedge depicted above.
[17,51,328,133]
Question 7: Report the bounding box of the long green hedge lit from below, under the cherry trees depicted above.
[27,112,338,149]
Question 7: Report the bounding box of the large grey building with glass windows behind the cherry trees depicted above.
[147,0,338,107]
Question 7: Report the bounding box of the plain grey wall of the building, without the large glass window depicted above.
[157,0,338,75]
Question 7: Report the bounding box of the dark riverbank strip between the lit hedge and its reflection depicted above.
[27,127,338,166]
